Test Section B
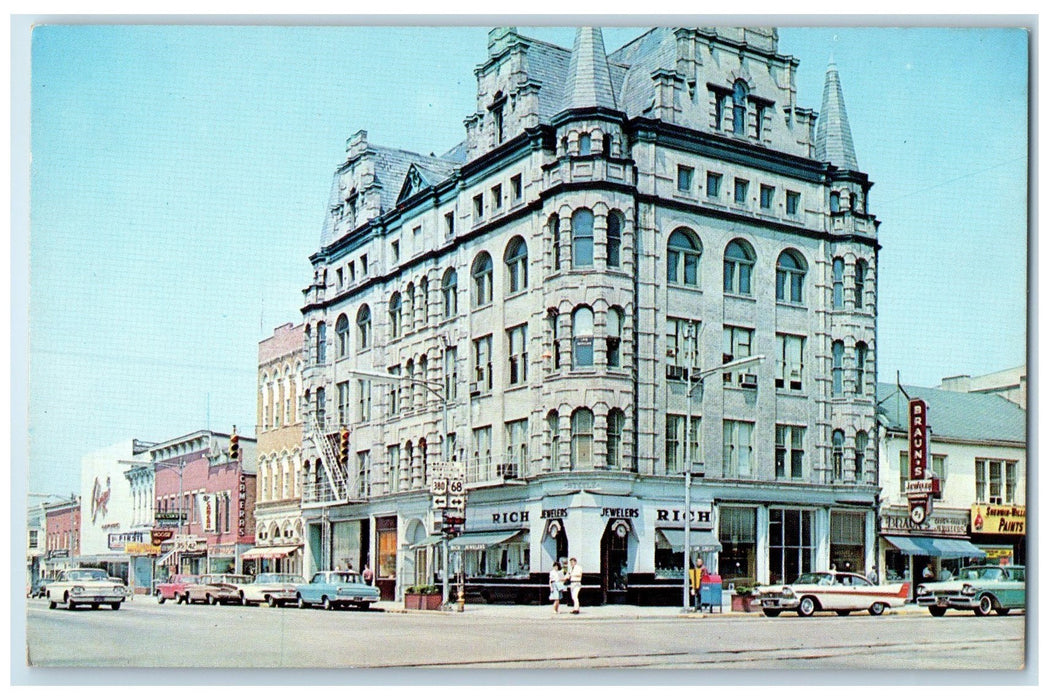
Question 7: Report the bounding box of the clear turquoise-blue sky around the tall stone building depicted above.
[20,25,1028,493]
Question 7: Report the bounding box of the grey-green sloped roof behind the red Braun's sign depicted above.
[878,383,1027,442]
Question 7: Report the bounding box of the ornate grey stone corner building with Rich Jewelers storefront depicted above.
[302,27,878,604]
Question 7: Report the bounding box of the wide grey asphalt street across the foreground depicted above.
[26,597,1026,671]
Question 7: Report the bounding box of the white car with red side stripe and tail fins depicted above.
[756,571,911,617]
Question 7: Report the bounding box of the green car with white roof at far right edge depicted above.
[917,565,1027,617]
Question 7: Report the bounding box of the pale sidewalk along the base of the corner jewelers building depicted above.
[372,600,928,620]
